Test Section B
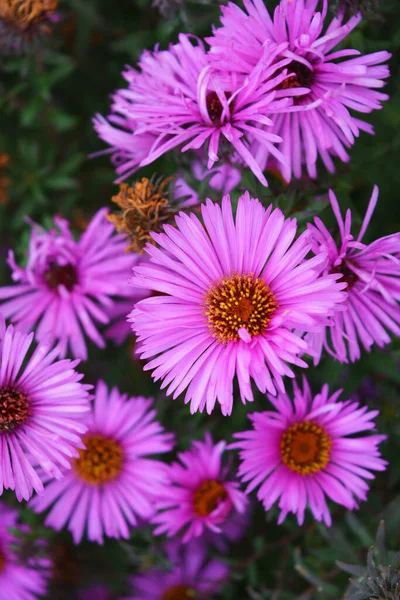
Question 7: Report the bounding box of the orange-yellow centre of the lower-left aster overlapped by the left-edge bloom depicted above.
[73,433,124,485]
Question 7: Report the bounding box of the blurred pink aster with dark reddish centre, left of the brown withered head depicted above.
[0,209,134,359]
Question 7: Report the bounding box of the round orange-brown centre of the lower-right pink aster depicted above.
[280,421,332,475]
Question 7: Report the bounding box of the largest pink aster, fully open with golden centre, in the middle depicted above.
[129,193,346,415]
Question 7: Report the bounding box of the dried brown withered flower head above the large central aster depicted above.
[107,177,177,254]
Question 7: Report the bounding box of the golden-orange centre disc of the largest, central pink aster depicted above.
[206,275,278,343]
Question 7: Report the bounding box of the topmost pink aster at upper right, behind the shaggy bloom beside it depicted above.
[207,0,391,181]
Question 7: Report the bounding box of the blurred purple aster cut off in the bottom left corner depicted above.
[0,502,50,600]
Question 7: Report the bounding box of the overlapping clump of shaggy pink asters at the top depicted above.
[94,0,390,191]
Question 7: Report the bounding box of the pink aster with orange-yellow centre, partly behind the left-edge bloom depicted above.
[31,381,174,544]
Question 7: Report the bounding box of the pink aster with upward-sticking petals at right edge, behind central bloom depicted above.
[306,186,400,363]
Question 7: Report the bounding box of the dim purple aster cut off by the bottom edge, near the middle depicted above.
[124,540,229,600]
